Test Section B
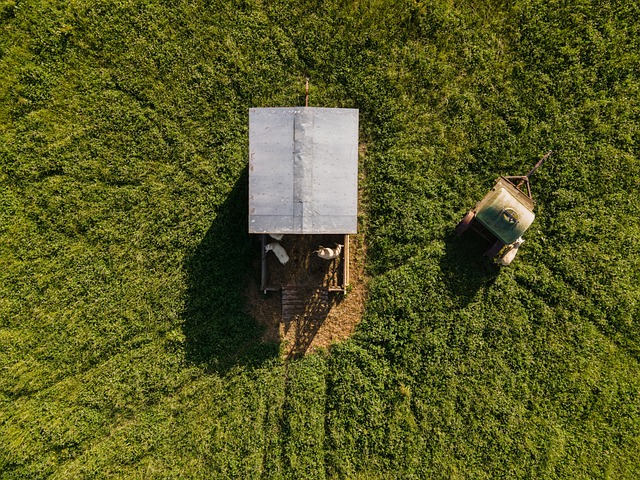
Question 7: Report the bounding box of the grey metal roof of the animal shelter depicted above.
[249,107,358,234]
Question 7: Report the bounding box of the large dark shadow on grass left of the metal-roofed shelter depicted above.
[183,169,278,373]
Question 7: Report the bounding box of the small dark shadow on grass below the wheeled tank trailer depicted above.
[440,232,500,308]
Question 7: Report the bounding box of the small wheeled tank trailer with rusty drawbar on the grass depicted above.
[456,151,552,259]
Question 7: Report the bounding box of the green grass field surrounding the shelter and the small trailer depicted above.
[0,0,640,479]
